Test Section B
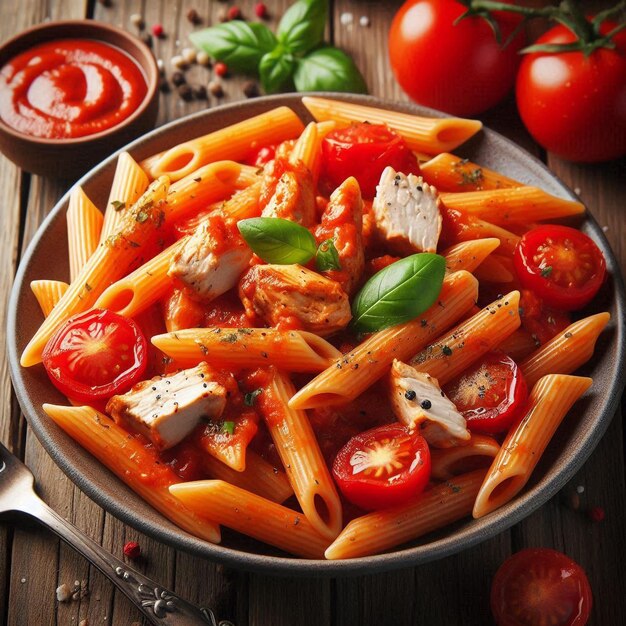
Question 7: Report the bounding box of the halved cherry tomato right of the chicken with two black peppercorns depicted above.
[445,352,528,433]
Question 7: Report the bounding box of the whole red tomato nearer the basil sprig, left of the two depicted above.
[389,0,524,115]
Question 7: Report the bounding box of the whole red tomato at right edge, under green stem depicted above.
[516,22,626,162]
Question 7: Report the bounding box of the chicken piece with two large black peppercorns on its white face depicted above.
[391,359,470,448]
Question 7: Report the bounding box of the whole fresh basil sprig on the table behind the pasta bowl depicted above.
[189,0,367,93]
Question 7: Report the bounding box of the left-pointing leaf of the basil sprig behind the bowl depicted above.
[189,20,277,74]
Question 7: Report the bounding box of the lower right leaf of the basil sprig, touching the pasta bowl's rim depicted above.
[293,46,367,93]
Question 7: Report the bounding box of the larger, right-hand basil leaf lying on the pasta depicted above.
[352,253,446,333]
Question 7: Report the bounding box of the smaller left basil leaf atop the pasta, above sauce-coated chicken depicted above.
[237,217,316,265]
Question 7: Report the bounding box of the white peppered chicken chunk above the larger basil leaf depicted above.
[372,167,442,255]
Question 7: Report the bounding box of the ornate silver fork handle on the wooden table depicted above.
[22,498,234,626]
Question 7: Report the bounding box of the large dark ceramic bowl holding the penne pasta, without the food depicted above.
[8,94,625,576]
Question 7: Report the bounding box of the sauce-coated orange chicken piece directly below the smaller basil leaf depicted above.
[239,265,352,337]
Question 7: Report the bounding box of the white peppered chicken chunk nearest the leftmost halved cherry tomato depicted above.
[106,363,226,450]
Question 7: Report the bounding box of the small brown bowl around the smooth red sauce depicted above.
[0,20,159,178]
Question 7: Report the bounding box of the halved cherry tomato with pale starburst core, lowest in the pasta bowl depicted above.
[333,424,430,511]
